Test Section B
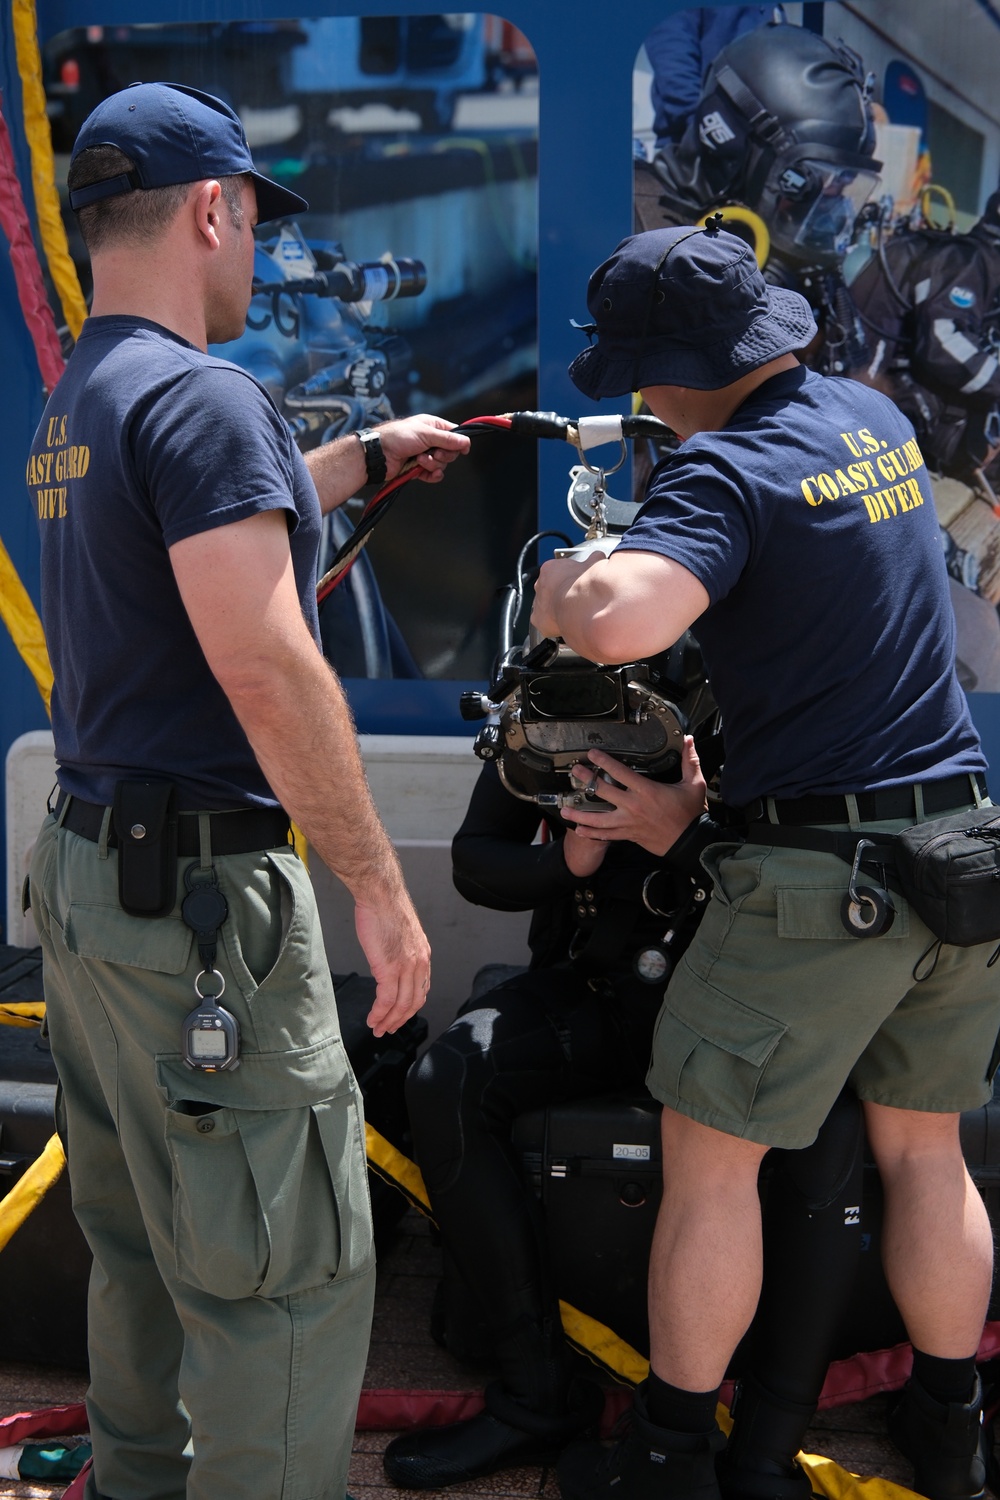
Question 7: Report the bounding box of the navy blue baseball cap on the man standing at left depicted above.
[69,84,309,224]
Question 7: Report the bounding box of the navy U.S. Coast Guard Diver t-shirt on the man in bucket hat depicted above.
[621,366,985,806]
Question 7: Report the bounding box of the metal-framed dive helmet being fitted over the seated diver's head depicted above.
[460,416,715,809]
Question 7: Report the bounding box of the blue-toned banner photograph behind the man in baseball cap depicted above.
[42,12,538,680]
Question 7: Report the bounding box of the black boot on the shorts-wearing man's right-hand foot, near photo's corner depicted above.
[889,1374,990,1500]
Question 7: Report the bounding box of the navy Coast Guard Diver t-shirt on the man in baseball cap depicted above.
[27,317,321,809]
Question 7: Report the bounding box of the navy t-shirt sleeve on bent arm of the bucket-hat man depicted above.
[619,444,756,605]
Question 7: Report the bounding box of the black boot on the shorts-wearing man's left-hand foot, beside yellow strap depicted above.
[556,1386,726,1500]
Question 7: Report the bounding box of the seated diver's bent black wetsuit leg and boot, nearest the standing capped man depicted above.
[385,969,654,1488]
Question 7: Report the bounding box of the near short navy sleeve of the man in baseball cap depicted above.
[129,363,298,548]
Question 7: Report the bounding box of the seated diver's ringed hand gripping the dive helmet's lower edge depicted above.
[562,735,706,855]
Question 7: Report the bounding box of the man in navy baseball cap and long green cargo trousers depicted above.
[27,84,468,1500]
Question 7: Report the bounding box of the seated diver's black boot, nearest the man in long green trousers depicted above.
[382,1319,604,1490]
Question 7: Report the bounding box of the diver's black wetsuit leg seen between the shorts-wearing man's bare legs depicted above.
[718,1089,864,1500]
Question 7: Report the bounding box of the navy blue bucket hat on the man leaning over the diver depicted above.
[570,221,816,401]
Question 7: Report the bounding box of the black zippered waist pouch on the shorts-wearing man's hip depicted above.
[892,807,1000,948]
